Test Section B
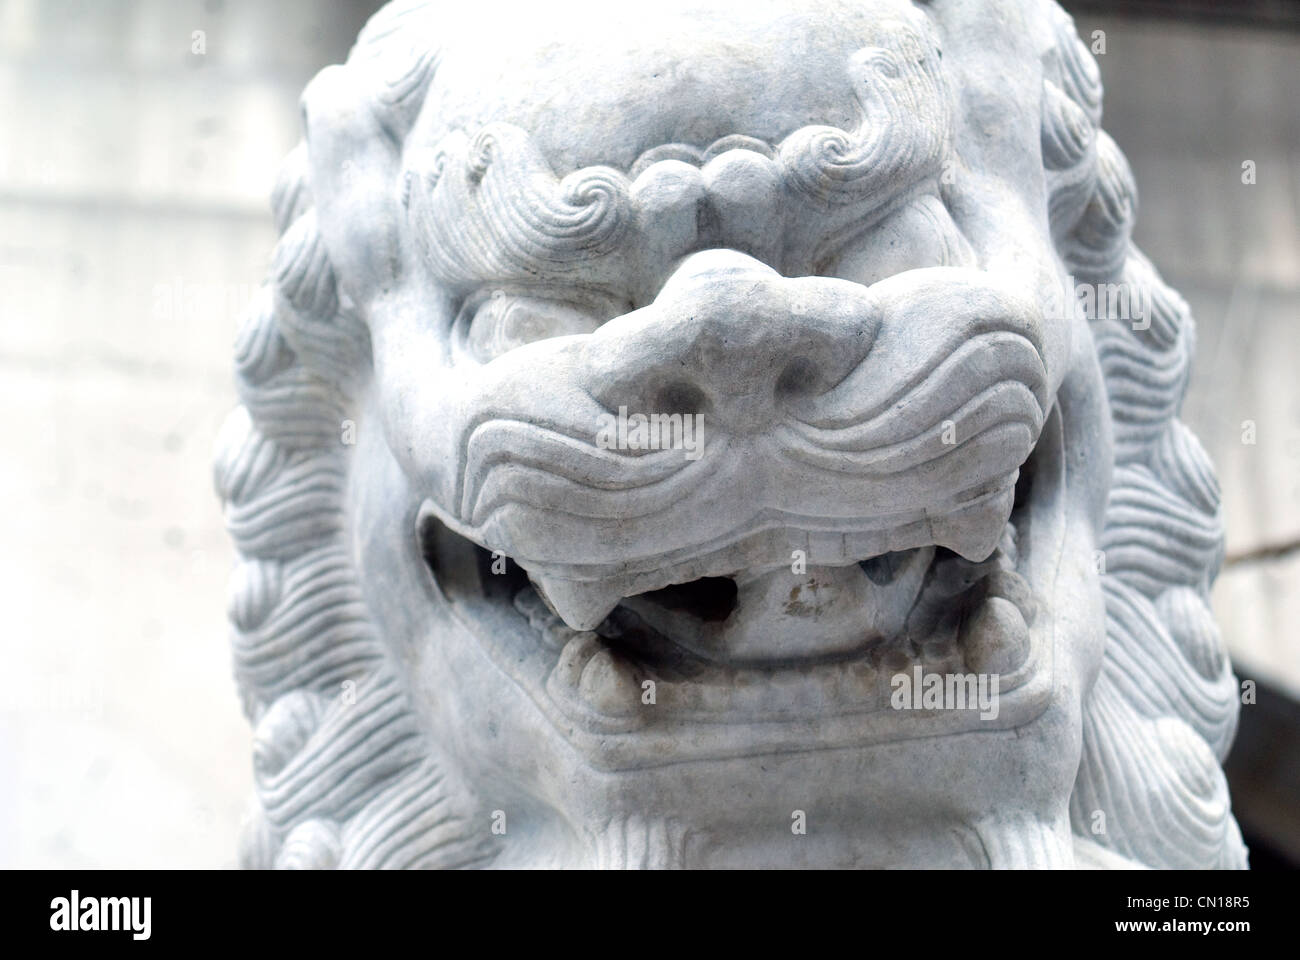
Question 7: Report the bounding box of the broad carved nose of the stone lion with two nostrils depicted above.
[584,250,879,433]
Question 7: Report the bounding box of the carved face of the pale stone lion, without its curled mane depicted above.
[335,4,1100,851]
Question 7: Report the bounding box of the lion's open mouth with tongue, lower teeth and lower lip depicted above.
[417,412,1065,767]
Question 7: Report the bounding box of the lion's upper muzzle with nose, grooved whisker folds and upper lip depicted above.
[413,250,1049,628]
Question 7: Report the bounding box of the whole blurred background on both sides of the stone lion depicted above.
[0,0,1300,868]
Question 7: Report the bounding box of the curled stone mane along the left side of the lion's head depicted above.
[215,5,490,868]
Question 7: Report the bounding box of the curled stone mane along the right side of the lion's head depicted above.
[1043,5,1245,869]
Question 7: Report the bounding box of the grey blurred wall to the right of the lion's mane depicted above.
[1078,14,1300,691]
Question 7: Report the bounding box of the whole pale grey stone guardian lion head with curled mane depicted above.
[216,0,1245,868]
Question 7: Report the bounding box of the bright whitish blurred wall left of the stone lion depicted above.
[0,0,372,868]
